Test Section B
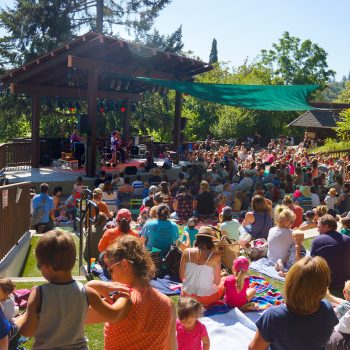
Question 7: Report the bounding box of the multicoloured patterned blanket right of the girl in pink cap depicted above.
[249,276,284,310]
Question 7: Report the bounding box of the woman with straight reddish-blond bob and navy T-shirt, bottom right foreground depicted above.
[249,256,338,350]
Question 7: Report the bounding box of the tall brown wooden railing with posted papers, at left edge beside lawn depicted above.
[0,182,30,260]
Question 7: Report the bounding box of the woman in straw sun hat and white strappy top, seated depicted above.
[179,226,225,306]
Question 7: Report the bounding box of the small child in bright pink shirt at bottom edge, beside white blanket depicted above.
[176,297,210,350]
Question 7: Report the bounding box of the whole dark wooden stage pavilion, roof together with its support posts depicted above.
[1,32,212,177]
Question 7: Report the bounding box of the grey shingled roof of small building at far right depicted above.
[288,102,350,129]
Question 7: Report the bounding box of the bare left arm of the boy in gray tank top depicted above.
[16,288,40,337]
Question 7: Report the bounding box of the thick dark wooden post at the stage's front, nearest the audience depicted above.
[86,71,98,177]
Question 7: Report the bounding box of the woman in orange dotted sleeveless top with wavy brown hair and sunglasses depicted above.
[86,235,177,350]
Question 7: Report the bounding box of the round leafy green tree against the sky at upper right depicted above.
[260,32,335,86]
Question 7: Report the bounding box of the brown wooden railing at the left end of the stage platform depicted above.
[0,142,32,171]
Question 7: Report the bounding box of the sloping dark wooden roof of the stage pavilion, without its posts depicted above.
[0,32,213,97]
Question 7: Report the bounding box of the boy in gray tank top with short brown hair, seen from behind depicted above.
[16,230,130,350]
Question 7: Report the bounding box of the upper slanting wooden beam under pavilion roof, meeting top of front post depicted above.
[68,55,174,79]
